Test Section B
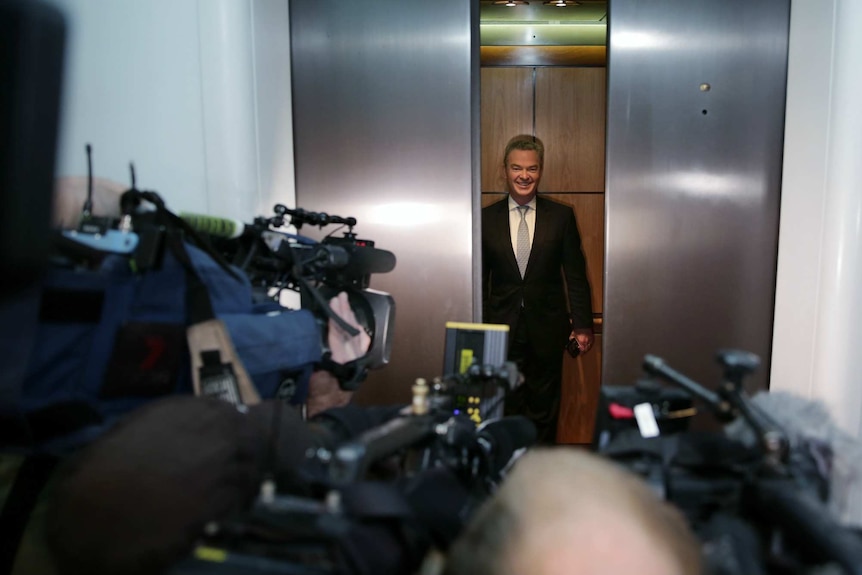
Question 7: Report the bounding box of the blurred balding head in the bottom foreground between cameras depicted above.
[445,448,701,575]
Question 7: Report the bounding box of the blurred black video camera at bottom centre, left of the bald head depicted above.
[170,364,535,575]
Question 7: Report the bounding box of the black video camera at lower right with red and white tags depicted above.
[594,350,862,575]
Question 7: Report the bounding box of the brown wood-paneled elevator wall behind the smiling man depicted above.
[480,64,606,443]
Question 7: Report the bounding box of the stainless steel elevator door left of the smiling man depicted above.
[290,0,479,403]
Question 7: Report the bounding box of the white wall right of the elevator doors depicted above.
[770,0,862,437]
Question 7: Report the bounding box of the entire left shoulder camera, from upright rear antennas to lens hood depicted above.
[57,151,396,390]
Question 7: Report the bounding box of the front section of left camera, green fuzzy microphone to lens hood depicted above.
[180,204,396,390]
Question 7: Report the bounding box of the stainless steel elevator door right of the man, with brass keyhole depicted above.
[602,0,792,387]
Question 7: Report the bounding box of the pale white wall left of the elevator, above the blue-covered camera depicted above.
[48,0,295,221]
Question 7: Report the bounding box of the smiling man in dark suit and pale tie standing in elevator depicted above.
[482,136,593,444]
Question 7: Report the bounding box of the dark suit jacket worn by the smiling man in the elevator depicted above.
[482,196,593,357]
